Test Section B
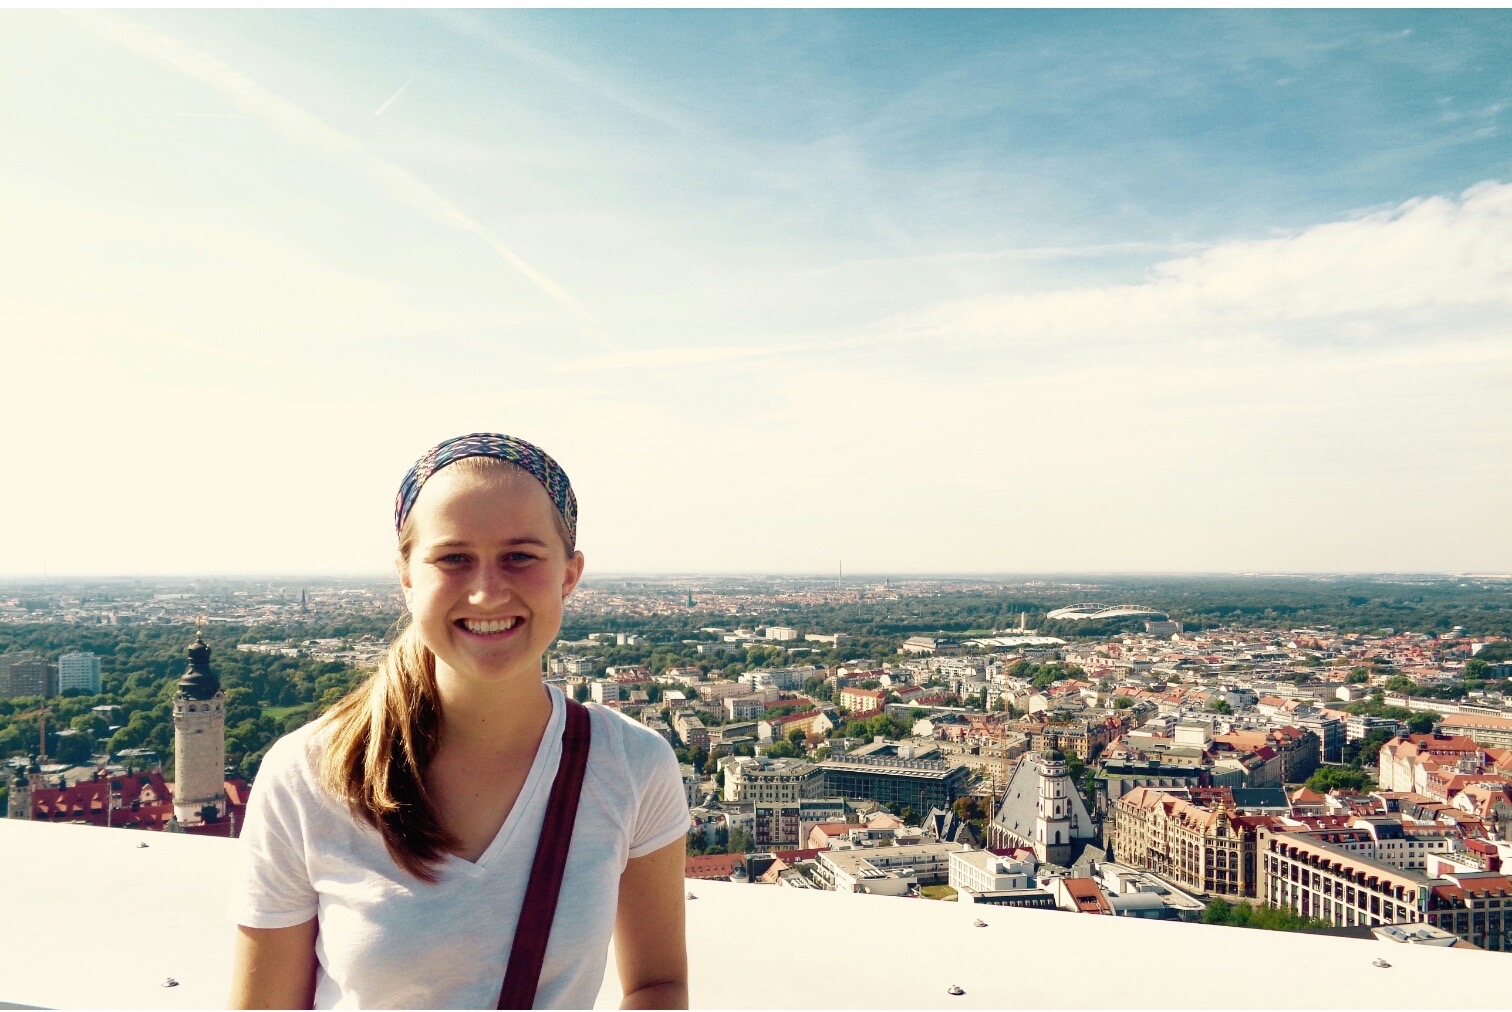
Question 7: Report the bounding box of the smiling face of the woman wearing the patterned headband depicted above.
[399,466,582,681]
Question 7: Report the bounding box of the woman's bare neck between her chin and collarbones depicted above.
[435,664,552,756]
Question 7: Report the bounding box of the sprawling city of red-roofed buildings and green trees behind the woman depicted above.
[0,575,1512,951]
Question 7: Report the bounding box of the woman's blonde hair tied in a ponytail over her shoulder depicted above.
[319,457,575,883]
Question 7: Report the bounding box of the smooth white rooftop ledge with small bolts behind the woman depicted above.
[0,820,1512,1009]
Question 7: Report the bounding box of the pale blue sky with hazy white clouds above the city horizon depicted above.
[0,11,1512,576]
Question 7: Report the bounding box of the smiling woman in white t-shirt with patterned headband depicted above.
[231,433,688,1009]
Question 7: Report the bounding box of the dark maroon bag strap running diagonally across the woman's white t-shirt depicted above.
[499,696,591,1009]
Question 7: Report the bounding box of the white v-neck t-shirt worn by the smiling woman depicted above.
[231,687,688,1009]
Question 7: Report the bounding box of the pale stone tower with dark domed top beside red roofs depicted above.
[174,634,225,823]
